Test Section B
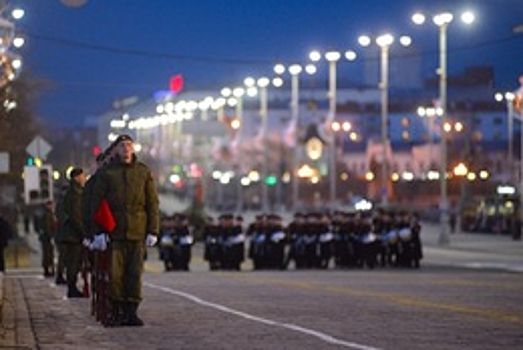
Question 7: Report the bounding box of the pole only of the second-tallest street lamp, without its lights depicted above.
[380,45,389,206]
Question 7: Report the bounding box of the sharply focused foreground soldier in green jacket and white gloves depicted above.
[90,135,160,326]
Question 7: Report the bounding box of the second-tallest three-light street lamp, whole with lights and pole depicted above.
[358,33,412,206]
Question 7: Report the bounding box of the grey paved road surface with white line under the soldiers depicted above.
[18,246,523,350]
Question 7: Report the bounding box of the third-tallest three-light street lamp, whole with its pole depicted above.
[309,51,356,209]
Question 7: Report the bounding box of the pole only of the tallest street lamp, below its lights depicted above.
[438,23,450,245]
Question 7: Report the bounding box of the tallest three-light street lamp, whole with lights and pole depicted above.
[412,11,474,245]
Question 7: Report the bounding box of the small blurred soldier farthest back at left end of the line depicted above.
[38,201,57,277]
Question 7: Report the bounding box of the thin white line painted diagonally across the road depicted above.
[144,282,380,350]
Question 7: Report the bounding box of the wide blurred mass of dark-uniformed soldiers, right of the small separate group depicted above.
[199,209,423,270]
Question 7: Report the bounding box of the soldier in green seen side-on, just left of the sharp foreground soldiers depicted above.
[60,168,86,298]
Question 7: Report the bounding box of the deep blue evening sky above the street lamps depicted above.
[19,0,523,126]
